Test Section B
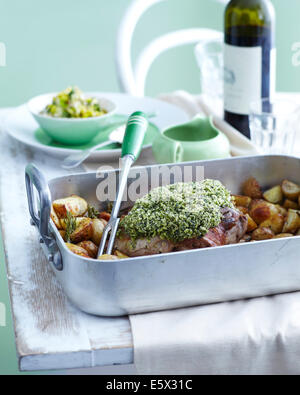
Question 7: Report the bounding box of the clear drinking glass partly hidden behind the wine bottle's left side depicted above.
[195,39,224,115]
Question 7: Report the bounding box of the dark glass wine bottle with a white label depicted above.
[224,0,276,137]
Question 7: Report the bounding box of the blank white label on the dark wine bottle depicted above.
[224,44,275,115]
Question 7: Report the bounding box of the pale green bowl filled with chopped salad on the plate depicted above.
[28,93,117,146]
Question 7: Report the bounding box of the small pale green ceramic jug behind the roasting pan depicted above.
[152,116,231,164]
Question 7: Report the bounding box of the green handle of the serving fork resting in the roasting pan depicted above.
[122,111,149,161]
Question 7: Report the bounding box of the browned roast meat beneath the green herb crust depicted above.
[115,208,248,257]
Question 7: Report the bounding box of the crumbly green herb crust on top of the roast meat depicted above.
[119,180,234,243]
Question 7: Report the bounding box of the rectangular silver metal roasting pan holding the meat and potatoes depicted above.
[26,156,300,316]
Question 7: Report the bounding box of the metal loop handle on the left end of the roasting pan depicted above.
[25,163,63,271]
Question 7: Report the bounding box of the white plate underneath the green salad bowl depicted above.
[4,92,189,159]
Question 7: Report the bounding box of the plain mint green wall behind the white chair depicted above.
[0,0,300,106]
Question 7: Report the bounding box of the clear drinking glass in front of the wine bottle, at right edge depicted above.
[249,99,300,155]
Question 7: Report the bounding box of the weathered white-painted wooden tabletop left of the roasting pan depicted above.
[0,110,140,371]
